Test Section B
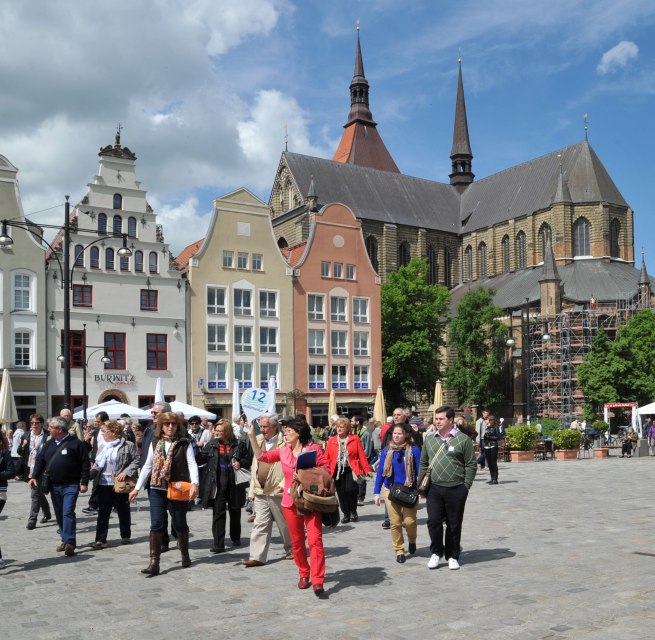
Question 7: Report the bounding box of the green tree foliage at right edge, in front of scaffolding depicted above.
[578,309,655,418]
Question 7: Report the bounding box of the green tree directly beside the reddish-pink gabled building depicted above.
[382,258,450,405]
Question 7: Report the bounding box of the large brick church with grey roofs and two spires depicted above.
[269,32,653,423]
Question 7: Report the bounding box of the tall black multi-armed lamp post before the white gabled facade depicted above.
[0,196,132,409]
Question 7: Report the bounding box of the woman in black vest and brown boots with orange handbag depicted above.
[130,411,198,576]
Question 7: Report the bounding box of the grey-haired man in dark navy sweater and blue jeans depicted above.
[29,417,91,557]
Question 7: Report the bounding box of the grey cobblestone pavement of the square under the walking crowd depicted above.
[0,457,655,640]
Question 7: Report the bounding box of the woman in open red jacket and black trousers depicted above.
[325,418,371,523]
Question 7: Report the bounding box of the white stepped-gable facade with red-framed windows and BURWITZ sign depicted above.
[48,134,187,412]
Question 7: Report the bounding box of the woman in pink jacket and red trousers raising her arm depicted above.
[248,419,328,596]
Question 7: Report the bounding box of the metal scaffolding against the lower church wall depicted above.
[525,295,651,426]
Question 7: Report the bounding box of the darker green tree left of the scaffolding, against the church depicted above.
[446,287,507,407]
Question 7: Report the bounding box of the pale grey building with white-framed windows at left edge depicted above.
[0,156,48,422]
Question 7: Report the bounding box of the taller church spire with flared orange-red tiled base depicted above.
[332,24,400,173]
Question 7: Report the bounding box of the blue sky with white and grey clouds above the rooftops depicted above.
[0,0,655,274]
